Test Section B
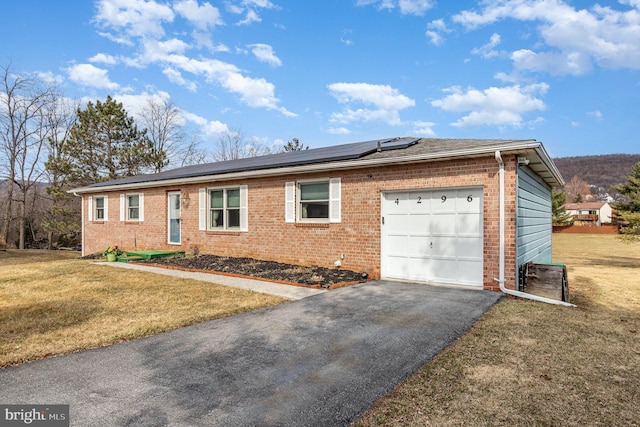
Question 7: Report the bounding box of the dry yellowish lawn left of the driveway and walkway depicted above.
[0,250,286,367]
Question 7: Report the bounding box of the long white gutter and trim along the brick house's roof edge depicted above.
[68,140,564,195]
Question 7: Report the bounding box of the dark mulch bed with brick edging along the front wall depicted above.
[138,255,367,288]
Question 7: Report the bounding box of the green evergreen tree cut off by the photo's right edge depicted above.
[614,163,640,242]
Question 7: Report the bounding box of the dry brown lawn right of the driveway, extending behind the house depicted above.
[355,234,640,426]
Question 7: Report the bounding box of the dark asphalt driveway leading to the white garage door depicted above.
[0,281,501,426]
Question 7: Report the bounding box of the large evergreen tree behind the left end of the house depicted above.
[47,96,158,185]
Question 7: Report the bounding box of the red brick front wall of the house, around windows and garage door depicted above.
[84,156,516,289]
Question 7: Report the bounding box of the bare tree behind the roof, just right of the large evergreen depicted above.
[140,98,205,172]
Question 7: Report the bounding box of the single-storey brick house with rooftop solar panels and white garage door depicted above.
[72,138,563,290]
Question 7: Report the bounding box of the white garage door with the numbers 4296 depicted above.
[381,187,483,286]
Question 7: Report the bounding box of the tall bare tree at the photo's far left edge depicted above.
[0,65,55,249]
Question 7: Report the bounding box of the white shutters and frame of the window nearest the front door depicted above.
[198,185,249,232]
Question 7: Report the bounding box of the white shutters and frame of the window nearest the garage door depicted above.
[285,178,342,224]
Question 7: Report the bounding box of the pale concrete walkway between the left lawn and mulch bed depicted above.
[95,262,326,300]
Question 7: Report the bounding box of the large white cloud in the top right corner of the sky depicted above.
[453,0,640,75]
